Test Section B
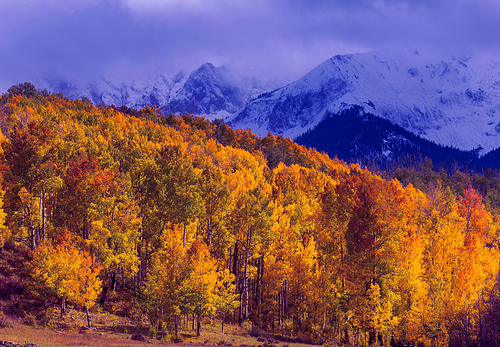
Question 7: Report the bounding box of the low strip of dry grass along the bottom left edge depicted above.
[0,310,316,347]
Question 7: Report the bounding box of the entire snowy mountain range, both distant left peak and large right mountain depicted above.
[43,48,500,155]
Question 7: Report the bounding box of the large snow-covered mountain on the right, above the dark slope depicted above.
[228,48,500,154]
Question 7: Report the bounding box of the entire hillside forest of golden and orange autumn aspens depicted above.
[0,83,500,346]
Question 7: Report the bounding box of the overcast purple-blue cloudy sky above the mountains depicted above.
[0,0,500,92]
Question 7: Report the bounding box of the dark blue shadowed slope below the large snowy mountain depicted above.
[295,106,479,168]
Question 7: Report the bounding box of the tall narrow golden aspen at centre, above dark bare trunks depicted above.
[221,148,275,321]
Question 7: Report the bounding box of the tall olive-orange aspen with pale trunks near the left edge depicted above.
[3,121,62,250]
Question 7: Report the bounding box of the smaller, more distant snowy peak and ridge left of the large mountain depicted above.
[44,63,267,119]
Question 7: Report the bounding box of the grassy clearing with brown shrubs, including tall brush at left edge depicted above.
[0,244,316,347]
